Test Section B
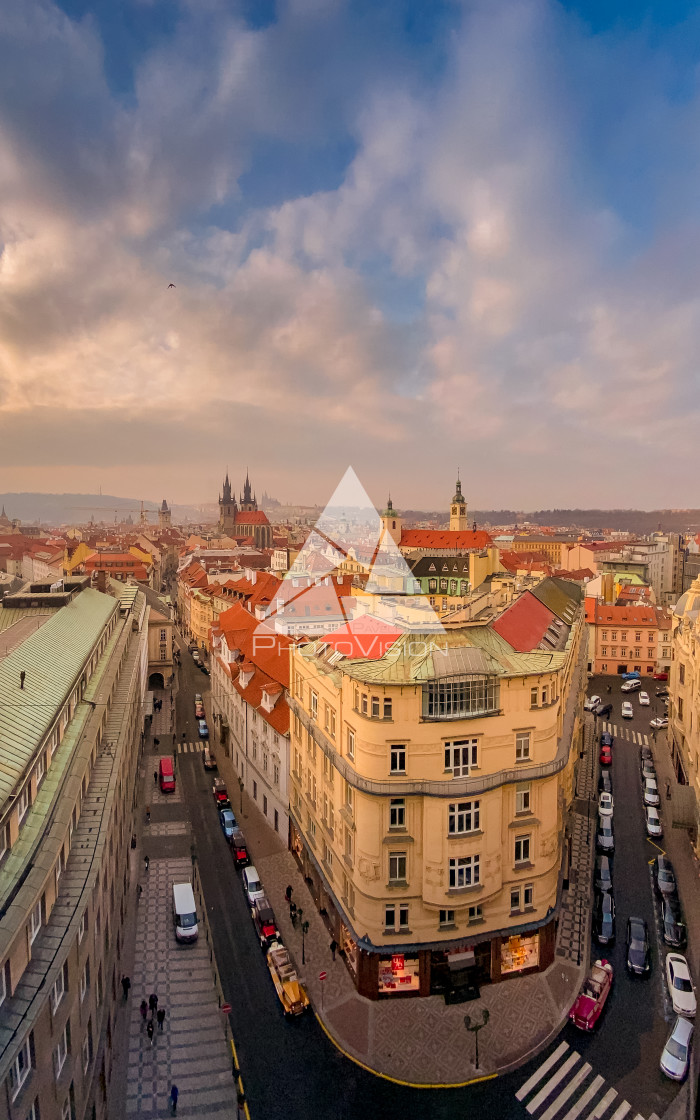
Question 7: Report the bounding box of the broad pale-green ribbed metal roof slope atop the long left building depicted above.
[0,588,119,812]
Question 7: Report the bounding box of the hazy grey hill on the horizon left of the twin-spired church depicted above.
[0,493,203,526]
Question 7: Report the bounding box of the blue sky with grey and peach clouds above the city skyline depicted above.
[0,0,700,510]
